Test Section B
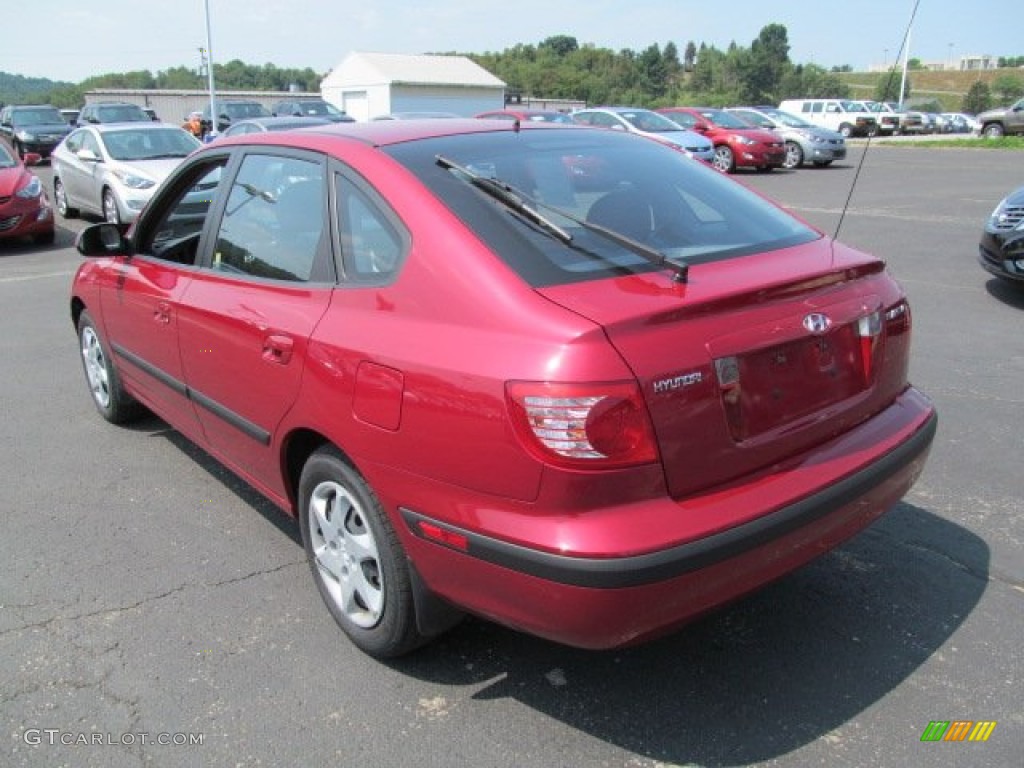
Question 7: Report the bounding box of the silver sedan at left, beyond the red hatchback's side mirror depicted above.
[50,122,202,224]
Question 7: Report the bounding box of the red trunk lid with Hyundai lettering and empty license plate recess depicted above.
[541,238,909,498]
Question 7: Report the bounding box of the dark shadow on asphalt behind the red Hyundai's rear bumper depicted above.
[392,503,989,766]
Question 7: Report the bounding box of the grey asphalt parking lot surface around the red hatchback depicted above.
[0,143,1024,768]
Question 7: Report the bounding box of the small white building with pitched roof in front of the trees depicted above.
[321,51,505,120]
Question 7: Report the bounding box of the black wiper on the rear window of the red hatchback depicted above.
[435,155,690,283]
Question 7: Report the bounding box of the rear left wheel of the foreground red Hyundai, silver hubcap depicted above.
[298,446,428,658]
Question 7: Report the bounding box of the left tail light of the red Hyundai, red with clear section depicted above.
[506,381,658,469]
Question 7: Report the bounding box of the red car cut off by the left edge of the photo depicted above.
[0,141,54,243]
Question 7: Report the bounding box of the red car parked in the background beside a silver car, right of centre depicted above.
[657,106,785,173]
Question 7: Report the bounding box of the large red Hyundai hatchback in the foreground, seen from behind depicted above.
[69,119,937,657]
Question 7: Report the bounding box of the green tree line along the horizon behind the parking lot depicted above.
[0,24,1024,112]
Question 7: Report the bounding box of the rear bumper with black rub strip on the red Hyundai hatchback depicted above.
[401,390,937,648]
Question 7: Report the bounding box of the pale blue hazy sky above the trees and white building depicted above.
[0,0,1024,83]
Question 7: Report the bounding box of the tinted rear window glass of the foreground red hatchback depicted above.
[384,128,821,287]
